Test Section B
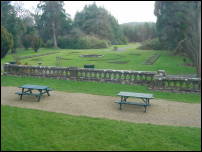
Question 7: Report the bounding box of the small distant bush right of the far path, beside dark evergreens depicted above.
[138,38,162,50]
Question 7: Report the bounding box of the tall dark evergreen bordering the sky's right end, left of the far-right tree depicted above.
[154,1,190,50]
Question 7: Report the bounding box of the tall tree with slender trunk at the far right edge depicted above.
[180,1,201,76]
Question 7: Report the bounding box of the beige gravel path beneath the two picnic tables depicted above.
[1,87,201,128]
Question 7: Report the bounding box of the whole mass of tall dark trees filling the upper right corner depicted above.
[154,1,201,75]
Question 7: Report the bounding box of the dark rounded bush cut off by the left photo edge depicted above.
[1,26,13,58]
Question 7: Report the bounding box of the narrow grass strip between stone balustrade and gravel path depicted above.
[1,76,201,103]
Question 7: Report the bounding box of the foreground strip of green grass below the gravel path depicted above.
[1,106,201,151]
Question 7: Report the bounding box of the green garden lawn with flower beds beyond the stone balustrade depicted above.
[1,43,196,74]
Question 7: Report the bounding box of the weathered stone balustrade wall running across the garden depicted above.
[4,64,201,92]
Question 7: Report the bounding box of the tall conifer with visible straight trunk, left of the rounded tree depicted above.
[35,1,69,48]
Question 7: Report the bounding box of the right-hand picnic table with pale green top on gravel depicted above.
[115,92,154,112]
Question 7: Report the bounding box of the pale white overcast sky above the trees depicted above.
[11,1,156,24]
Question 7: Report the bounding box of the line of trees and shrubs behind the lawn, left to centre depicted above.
[1,1,127,56]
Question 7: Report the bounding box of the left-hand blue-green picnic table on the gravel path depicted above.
[16,84,52,101]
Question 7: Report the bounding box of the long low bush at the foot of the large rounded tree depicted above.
[58,35,110,49]
